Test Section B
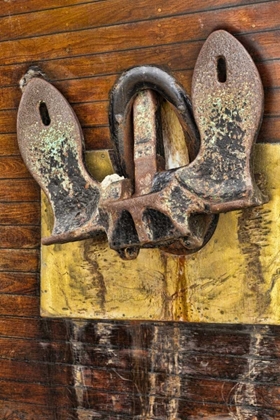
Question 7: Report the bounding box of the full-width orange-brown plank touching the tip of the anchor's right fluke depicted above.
[1,1,280,64]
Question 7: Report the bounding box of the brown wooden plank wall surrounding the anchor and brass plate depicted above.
[0,0,280,420]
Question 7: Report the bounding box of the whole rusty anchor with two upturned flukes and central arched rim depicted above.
[17,30,265,259]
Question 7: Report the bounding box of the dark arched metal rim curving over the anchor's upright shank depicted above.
[109,66,200,179]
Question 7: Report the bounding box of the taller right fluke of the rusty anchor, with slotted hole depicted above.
[176,31,263,212]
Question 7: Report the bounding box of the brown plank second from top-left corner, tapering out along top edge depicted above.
[0,0,270,41]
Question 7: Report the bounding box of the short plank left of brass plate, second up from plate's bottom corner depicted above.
[0,272,39,296]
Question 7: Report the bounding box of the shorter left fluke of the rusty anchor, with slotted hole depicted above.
[17,78,100,244]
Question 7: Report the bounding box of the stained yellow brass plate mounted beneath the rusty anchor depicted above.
[41,144,280,324]
